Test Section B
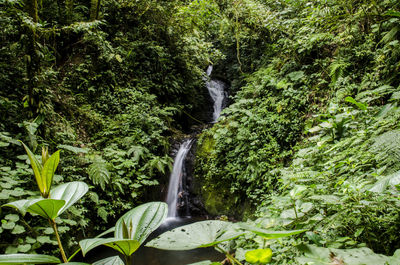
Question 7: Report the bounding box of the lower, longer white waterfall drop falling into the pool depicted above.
[167,139,193,217]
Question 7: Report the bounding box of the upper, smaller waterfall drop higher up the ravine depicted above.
[206,65,226,123]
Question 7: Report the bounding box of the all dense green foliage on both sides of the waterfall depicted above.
[0,0,400,264]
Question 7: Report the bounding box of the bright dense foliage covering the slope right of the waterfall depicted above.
[197,1,400,264]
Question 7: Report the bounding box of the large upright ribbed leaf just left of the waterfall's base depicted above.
[114,202,168,241]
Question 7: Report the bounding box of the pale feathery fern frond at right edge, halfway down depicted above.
[371,130,400,170]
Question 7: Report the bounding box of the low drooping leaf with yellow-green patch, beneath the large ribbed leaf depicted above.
[79,238,140,256]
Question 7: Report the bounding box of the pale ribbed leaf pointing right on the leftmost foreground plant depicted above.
[50,181,89,215]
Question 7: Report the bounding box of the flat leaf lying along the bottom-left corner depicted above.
[0,254,60,265]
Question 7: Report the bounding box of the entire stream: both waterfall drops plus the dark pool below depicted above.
[133,66,227,265]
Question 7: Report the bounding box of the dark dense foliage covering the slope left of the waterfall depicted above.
[0,0,219,253]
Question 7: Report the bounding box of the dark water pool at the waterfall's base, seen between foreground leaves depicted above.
[86,218,224,265]
